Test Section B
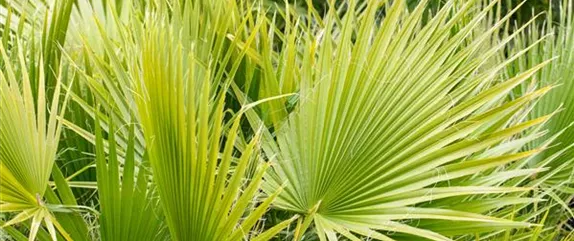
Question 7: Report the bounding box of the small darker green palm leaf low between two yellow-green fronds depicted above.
[96,114,168,240]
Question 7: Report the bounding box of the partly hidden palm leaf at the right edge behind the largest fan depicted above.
[507,1,574,236]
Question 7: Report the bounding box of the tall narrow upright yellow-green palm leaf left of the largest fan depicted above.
[130,2,300,240]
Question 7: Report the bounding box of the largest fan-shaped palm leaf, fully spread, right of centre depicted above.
[265,1,560,240]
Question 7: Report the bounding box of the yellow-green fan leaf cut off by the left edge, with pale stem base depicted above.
[0,46,71,240]
